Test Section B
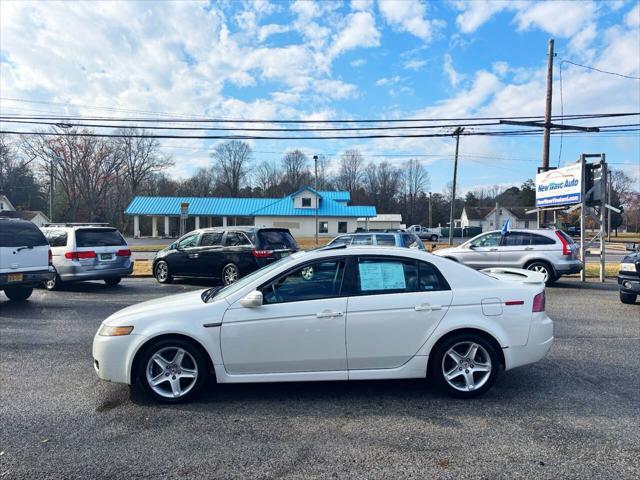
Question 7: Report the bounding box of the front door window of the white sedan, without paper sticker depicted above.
[260,259,344,304]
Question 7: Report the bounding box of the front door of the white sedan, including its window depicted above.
[220,258,347,374]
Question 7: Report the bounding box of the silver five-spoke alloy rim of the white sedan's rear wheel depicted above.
[442,341,492,392]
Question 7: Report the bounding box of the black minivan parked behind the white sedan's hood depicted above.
[153,227,299,285]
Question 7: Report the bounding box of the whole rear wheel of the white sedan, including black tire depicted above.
[430,333,500,398]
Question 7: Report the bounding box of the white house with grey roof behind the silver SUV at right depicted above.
[460,204,538,232]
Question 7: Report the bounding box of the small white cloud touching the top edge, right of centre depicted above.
[378,0,444,42]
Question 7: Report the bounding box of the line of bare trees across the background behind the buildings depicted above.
[0,127,638,230]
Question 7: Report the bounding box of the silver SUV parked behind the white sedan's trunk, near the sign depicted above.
[434,229,582,285]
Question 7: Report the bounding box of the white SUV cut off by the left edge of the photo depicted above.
[0,218,54,301]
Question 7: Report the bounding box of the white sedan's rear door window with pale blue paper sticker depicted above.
[356,257,418,295]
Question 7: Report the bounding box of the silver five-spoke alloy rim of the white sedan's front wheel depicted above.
[146,347,198,398]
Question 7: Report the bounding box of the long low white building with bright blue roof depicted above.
[124,187,376,237]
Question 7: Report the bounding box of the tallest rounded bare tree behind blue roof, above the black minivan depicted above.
[211,140,252,197]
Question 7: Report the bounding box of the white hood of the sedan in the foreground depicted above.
[103,290,229,325]
